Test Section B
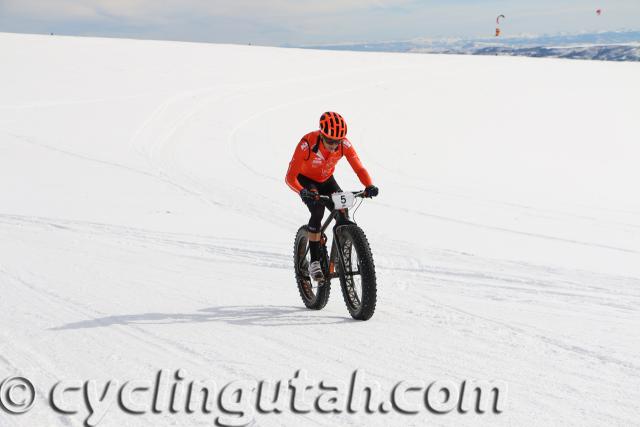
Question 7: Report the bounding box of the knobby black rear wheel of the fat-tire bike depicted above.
[293,225,331,310]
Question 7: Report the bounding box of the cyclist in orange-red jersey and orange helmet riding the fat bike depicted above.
[285,111,378,280]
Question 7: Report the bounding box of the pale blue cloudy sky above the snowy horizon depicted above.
[0,0,640,45]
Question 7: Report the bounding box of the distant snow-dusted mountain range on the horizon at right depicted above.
[302,31,640,61]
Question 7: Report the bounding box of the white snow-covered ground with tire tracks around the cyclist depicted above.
[0,34,640,426]
